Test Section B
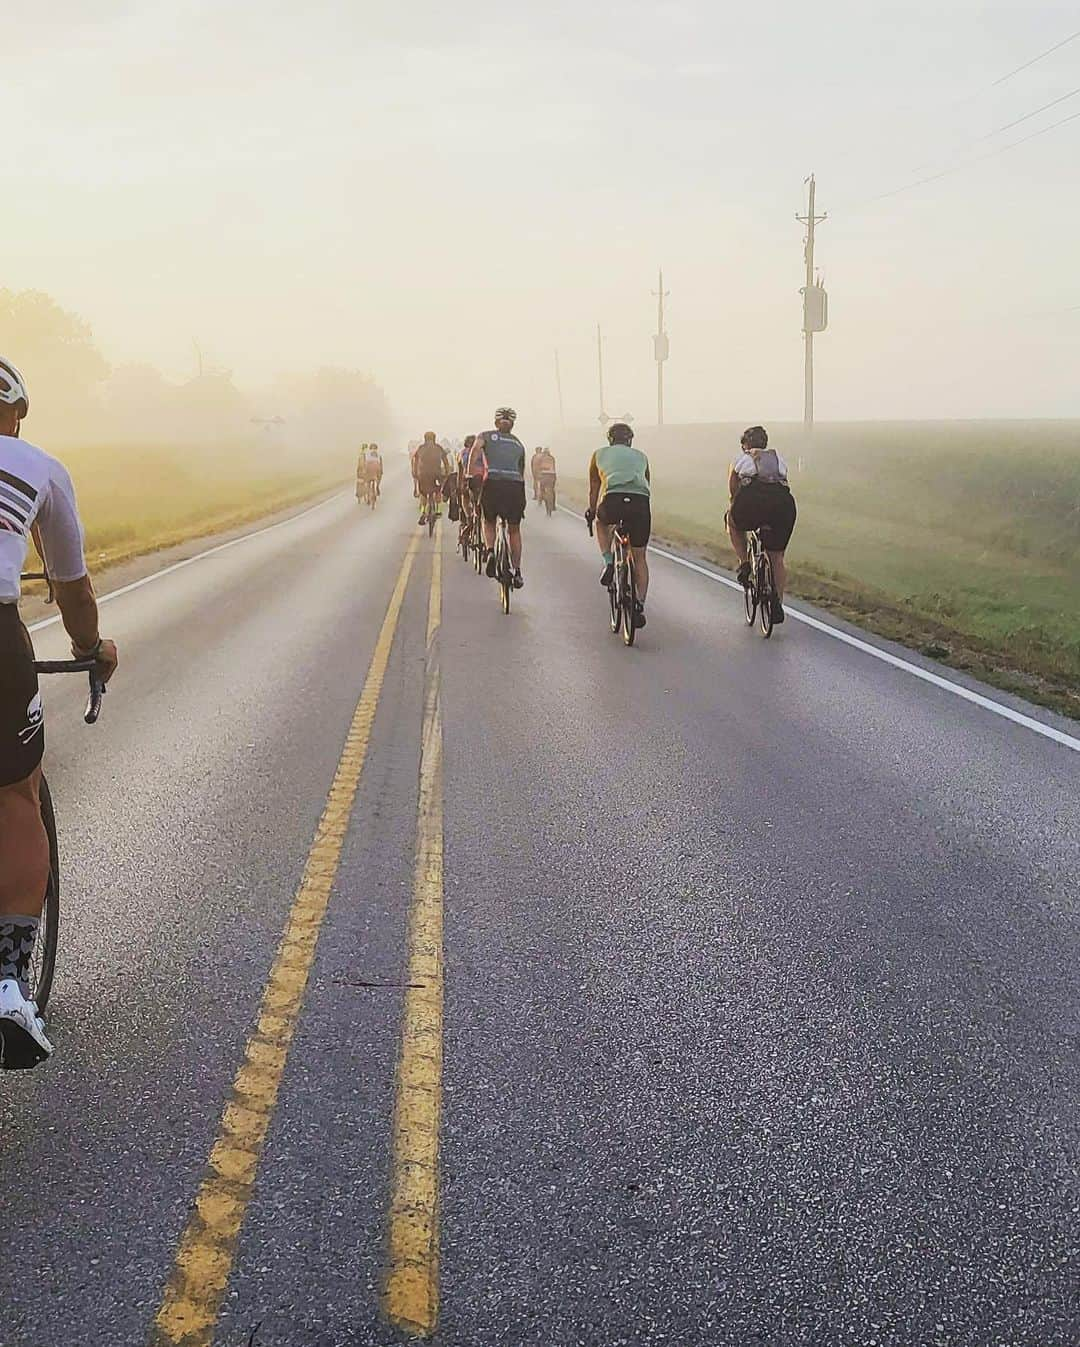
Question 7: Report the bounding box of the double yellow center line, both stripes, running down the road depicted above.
[149,533,443,1347]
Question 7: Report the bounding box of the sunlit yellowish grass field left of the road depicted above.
[51,445,340,570]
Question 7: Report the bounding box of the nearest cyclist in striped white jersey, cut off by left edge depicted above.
[0,360,116,1070]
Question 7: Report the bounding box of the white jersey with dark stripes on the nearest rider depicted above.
[0,435,86,603]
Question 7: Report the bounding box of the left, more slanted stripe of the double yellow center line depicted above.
[149,533,417,1347]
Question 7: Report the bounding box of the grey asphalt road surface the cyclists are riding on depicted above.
[0,492,1080,1347]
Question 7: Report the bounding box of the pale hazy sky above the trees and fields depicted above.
[0,0,1080,438]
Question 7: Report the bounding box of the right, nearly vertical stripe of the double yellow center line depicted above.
[384,528,443,1338]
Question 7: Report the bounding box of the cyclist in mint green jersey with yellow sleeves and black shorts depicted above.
[586,422,652,626]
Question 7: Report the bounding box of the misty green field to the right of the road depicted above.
[553,422,1080,715]
